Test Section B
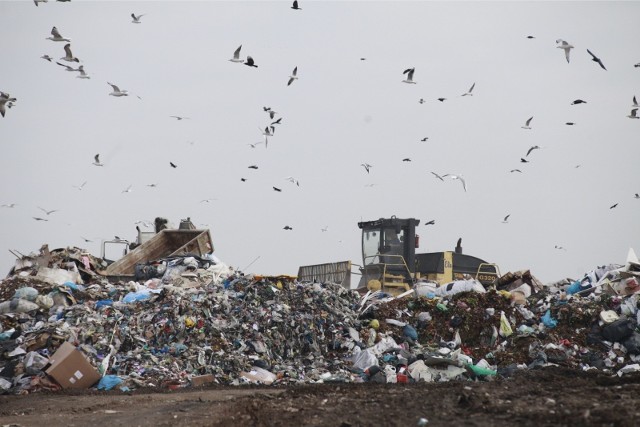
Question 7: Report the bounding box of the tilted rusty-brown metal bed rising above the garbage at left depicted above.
[101,230,213,278]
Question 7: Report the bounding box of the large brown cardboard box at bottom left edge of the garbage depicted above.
[45,341,101,388]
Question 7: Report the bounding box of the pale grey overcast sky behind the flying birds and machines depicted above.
[0,0,640,282]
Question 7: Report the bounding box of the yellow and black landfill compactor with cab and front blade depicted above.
[298,216,500,295]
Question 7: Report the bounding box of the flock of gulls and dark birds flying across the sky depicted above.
[0,0,640,268]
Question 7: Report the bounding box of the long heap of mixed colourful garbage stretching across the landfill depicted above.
[0,247,640,394]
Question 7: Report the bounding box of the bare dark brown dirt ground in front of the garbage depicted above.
[0,367,640,427]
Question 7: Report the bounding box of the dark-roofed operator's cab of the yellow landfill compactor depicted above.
[358,216,420,294]
